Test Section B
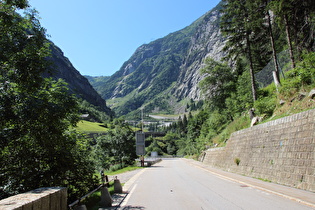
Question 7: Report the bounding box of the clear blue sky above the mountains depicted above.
[29,0,220,76]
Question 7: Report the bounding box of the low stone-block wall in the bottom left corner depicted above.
[0,187,67,210]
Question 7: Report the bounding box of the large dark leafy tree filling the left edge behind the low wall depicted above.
[0,0,94,201]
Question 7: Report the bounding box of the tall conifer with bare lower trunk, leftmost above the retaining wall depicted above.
[220,0,267,101]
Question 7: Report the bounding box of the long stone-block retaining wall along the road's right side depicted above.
[203,109,315,192]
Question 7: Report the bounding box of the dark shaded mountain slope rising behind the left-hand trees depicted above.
[44,43,111,114]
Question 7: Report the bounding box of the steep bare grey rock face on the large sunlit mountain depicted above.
[175,9,224,100]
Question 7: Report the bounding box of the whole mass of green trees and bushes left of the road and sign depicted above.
[0,0,136,203]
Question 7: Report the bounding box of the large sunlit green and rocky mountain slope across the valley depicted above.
[89,3,224,115]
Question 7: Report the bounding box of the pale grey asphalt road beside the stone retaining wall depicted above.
[120,159,313,210]
